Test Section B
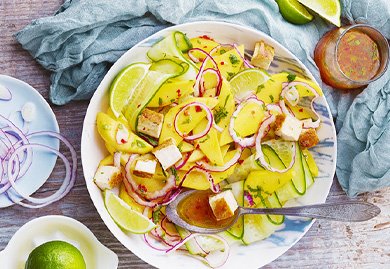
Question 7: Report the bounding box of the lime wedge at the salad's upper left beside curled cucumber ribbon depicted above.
[110,63,150,117]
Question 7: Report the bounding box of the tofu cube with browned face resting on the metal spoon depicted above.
[209,190,238,220]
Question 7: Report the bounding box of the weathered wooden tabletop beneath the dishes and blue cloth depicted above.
[0,0,390,269]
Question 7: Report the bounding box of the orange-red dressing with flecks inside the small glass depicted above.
[337,30,380,81]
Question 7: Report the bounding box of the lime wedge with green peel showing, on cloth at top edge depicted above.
[276,0,313,24]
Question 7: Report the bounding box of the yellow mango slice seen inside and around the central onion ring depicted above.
[159,97,218,145]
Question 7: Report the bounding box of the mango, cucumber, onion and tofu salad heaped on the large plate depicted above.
[94,31,322,267]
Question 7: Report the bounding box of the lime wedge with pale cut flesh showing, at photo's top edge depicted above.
[298,0,341,27]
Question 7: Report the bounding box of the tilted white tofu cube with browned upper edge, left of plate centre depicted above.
[152,138,182,170]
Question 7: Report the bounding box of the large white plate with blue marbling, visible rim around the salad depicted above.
[81,22,336,269]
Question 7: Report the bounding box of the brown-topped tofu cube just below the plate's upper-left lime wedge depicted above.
[137,108,164,138]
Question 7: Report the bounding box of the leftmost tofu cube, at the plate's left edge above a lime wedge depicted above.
[93,165,122,190]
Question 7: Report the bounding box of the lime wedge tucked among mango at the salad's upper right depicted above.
[229,69,269,95]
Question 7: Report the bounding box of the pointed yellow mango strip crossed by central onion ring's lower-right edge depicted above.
[194,119,224,166]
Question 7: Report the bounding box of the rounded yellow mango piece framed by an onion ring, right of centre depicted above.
[234,102,264,137]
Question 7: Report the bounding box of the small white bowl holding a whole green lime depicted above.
[0,215,118,269]
